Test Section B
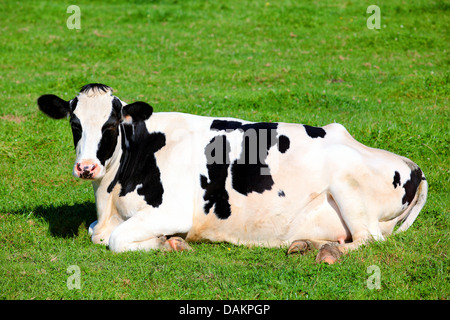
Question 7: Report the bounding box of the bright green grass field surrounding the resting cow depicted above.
[0,0,450,299]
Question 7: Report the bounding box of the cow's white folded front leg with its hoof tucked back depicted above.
[109,212,191,252]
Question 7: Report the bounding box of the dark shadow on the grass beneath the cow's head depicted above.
[33,202,97,238]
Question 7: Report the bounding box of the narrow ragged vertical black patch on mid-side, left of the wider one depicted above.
[200,135,231,219]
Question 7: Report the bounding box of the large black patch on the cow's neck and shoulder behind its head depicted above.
[108,112,166,208]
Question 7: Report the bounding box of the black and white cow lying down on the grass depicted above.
[37,83,428,264]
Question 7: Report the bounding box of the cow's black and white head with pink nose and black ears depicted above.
[38,83,153,180]
